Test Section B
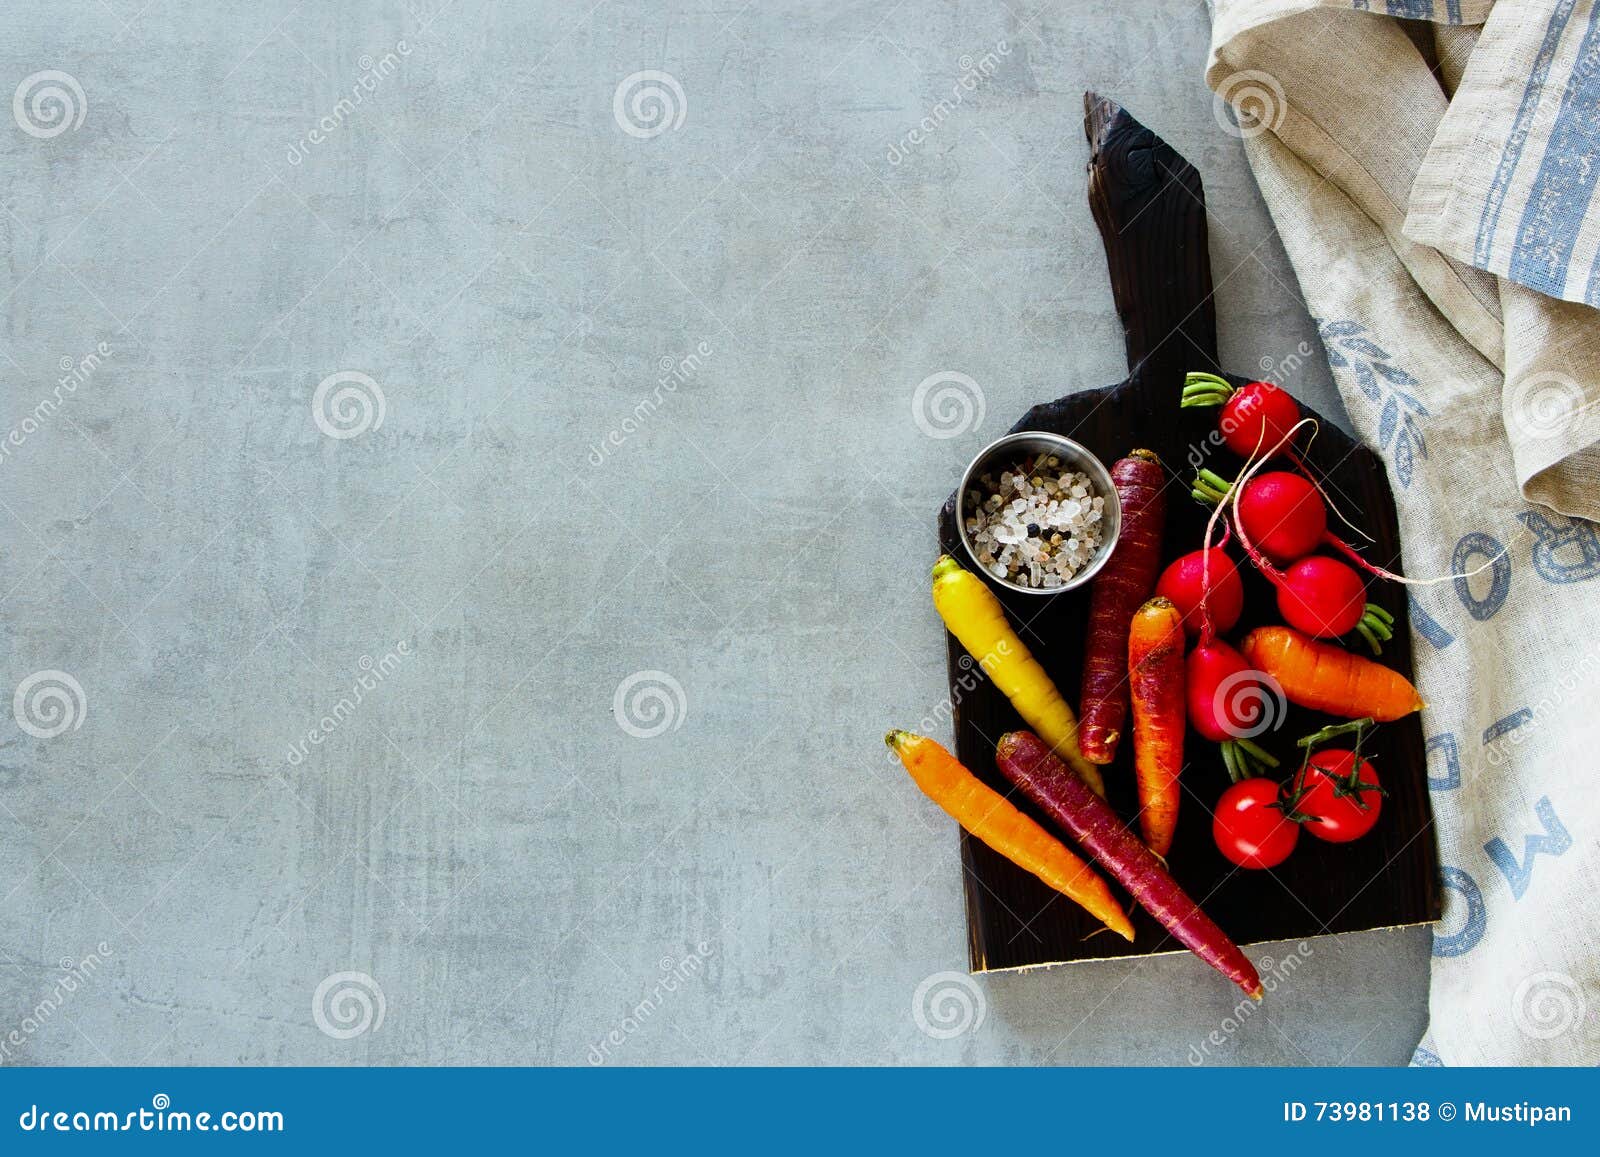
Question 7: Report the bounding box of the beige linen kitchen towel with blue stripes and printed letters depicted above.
[1206,0,1600,1064]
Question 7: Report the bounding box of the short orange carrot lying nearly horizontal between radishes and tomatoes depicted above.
[1240,627,1426,723]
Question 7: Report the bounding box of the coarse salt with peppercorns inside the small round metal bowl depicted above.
[966,454,1106,591]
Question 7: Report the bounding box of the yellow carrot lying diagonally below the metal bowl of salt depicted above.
[933,555,1106,799]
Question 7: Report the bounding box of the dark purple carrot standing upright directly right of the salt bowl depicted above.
[1078,450,1166,763]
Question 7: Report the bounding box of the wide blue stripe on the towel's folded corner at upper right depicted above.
[1507,8,1600,298]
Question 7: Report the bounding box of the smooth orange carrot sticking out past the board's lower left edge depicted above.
[883,731,1133,941]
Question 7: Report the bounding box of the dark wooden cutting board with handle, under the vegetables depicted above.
[939,93,1442,971]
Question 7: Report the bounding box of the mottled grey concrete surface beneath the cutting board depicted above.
[0,0,1429,1064]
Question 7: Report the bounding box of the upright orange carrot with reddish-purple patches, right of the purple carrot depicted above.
[1128,599,1184,856]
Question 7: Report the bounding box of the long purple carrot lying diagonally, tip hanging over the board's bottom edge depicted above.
[995,731,1260,999]
